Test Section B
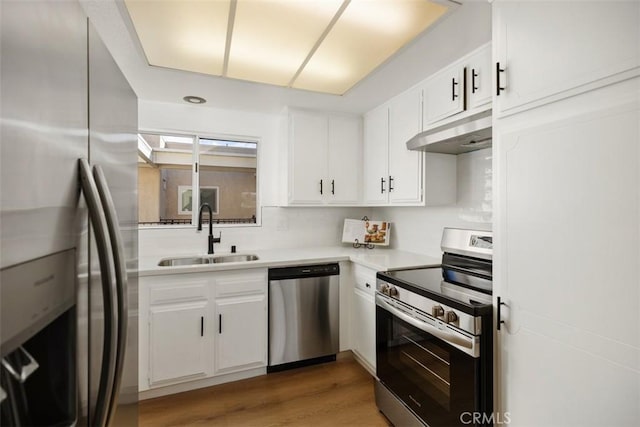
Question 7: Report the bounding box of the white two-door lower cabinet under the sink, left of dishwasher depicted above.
[139,269,267,391]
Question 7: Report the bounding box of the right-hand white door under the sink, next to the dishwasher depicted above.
[215,295,267,373]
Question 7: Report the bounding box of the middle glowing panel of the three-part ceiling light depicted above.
[227,0,342,86]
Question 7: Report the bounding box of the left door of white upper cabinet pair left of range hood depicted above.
[362,105,389,205]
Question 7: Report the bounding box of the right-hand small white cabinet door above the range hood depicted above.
[467,45,493,110]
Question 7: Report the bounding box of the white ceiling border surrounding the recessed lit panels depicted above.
[79,0,491,113]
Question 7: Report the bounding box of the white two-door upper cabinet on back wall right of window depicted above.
[287,110,362,205]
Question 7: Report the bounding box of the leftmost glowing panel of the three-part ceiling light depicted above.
[125,0,230,75]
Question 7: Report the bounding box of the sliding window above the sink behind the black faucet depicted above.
[138,132,258,225]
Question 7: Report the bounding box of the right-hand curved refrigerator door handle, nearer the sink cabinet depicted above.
[93,165,129,425]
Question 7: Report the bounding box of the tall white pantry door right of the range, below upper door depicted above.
[494,78,640,426]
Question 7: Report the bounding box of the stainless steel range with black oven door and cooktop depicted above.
[375,228,493,427]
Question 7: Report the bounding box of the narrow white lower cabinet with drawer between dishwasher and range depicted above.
[351,265,376,374]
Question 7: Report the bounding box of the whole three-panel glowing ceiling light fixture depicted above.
[125,0,458,96]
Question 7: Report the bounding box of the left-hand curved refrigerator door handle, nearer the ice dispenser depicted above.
[78,159,117,427]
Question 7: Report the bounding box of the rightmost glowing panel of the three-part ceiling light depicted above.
[292,0,447,94]
